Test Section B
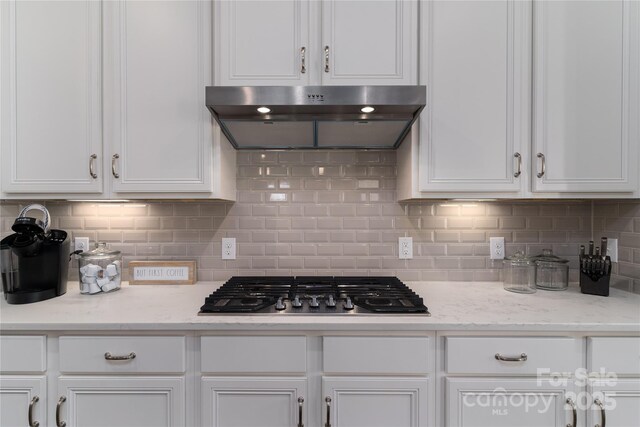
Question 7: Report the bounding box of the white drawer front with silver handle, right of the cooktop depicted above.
[445,337,582,375]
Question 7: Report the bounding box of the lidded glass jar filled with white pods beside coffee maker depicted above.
[78,242,122,295]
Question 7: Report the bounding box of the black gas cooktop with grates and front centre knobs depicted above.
[198,276,430,316]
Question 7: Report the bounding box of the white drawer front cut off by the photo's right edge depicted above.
[587,337,640,375]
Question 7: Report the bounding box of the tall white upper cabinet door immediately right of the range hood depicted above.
[420,0,531,193]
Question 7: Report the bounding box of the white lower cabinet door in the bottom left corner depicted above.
[0,376,47,427]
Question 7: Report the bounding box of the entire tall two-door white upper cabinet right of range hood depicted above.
[398,0,640,200]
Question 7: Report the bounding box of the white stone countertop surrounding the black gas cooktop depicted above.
[0,282,640,334]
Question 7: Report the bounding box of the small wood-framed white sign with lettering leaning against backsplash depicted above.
[129,261,196,285]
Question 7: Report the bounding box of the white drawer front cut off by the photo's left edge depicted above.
[0,335,47,373]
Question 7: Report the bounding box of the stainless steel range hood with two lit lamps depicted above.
[206,86,427,150]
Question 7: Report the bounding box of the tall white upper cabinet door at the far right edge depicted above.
[532,0,640,192]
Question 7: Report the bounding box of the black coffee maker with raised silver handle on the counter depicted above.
[0,204,70,304]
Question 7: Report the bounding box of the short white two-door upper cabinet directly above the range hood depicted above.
[214,0,418,86]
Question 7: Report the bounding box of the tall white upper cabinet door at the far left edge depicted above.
[0,0,102,193]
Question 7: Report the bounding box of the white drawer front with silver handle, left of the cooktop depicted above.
[60,336,186,373]
